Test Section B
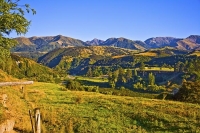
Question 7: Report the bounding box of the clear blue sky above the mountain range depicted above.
[10,0,200,41]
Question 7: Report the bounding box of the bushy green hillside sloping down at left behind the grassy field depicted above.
[0,54,59,82]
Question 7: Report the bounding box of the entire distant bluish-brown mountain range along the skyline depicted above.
[12,35,200,52]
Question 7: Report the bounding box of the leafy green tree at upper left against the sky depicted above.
[0,0,36,56]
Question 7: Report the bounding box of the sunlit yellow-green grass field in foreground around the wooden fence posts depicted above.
[2,83,200,133]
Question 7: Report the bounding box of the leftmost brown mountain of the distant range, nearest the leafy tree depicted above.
[12,35,88,52]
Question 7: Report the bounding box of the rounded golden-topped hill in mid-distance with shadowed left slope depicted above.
[38,46,135,67]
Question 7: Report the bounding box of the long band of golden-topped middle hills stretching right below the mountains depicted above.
[38,46,194,75]
